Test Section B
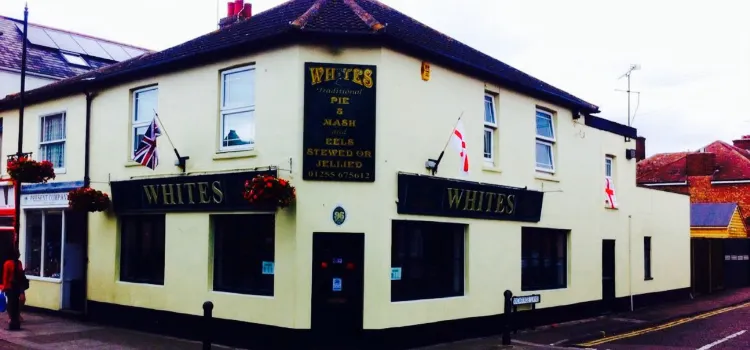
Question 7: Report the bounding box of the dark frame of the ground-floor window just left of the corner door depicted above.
[210,213,278,298]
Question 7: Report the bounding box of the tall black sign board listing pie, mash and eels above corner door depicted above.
[302,62,377,182]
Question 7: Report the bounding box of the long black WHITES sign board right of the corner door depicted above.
[397,173,544,222]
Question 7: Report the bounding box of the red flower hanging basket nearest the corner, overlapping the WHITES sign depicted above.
[243,175,297,208]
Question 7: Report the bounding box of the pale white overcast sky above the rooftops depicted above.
[0,0,750,156]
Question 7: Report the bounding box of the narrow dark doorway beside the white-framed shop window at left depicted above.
[62,211,86,312]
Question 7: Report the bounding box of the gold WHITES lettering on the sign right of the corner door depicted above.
[447,187,516,215]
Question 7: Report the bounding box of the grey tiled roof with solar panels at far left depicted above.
[0,16,151,91]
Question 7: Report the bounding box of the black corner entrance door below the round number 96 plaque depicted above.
[311,233,365,345]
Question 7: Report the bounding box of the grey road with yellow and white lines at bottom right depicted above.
[578,303,750,350]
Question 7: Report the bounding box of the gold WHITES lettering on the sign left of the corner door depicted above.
[143,181,224,206]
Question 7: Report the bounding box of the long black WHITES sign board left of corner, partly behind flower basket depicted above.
[111,170,277,214]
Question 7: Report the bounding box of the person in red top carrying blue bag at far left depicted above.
[3,248,28,331]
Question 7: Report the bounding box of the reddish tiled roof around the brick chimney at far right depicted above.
[637,141,750,183]
